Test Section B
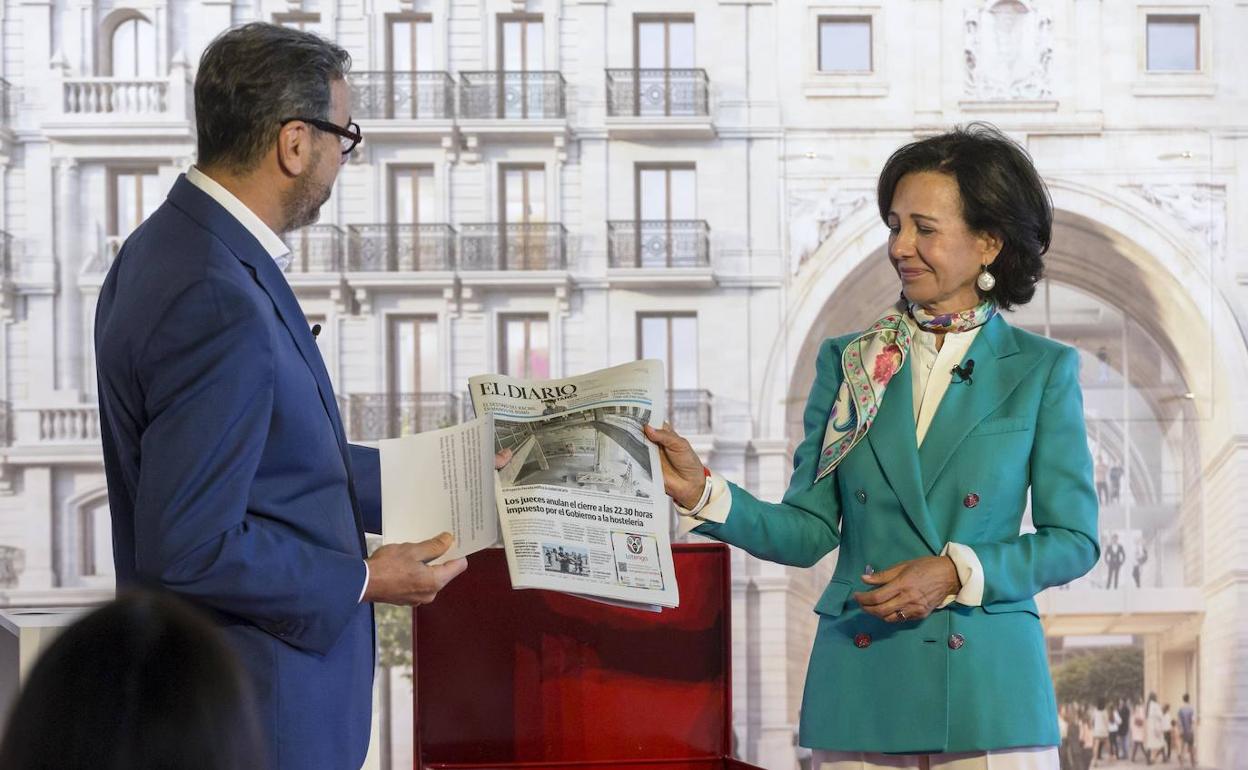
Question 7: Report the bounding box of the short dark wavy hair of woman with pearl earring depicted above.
[876,122,1053,309]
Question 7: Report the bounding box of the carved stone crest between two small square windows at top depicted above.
[963,0,1053,101]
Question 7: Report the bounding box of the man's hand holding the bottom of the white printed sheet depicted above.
[363,532,468,607]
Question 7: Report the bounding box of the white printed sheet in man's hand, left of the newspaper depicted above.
[378,416,498,564]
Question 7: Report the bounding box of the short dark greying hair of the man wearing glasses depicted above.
[195,21,351,173]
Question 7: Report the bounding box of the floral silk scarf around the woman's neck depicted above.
[815,301,997,482]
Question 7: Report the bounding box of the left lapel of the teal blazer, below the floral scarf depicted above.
[866,357,943,554]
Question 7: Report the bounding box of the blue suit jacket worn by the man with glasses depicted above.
[95,177,381,770]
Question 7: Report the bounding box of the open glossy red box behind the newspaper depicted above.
[412,544,751,770]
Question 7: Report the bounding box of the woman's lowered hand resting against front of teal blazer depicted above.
[854,557,962,623]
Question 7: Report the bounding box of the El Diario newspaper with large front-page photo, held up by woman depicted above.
[468,361,679,608]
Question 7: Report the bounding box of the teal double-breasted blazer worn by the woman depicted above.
[696,316,1099,754]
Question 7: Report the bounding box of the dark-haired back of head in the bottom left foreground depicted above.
[0,592,268,770]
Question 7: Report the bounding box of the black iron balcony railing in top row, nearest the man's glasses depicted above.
[351,72,456,120]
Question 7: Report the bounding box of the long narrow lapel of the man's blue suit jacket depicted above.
[168,175,364,544]
